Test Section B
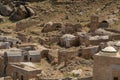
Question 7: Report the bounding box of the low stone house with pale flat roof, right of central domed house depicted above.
[77,33,111,47]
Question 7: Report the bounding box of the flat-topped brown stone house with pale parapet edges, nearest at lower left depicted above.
[7,62,41,80]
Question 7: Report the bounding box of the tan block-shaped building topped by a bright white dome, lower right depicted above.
[93,46,120,80]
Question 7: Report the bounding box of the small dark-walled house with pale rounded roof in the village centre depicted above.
[60,34,79,48]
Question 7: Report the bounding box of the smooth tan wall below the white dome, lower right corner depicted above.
[93,55,120,80]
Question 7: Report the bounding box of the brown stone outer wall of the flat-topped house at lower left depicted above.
[7,65,41,80]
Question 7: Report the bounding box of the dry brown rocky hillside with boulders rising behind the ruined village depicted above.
[0,0,120,35]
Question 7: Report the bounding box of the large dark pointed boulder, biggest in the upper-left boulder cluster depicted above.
[9,5,28,21]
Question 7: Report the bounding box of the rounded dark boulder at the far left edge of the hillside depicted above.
[0,5,13,16]
